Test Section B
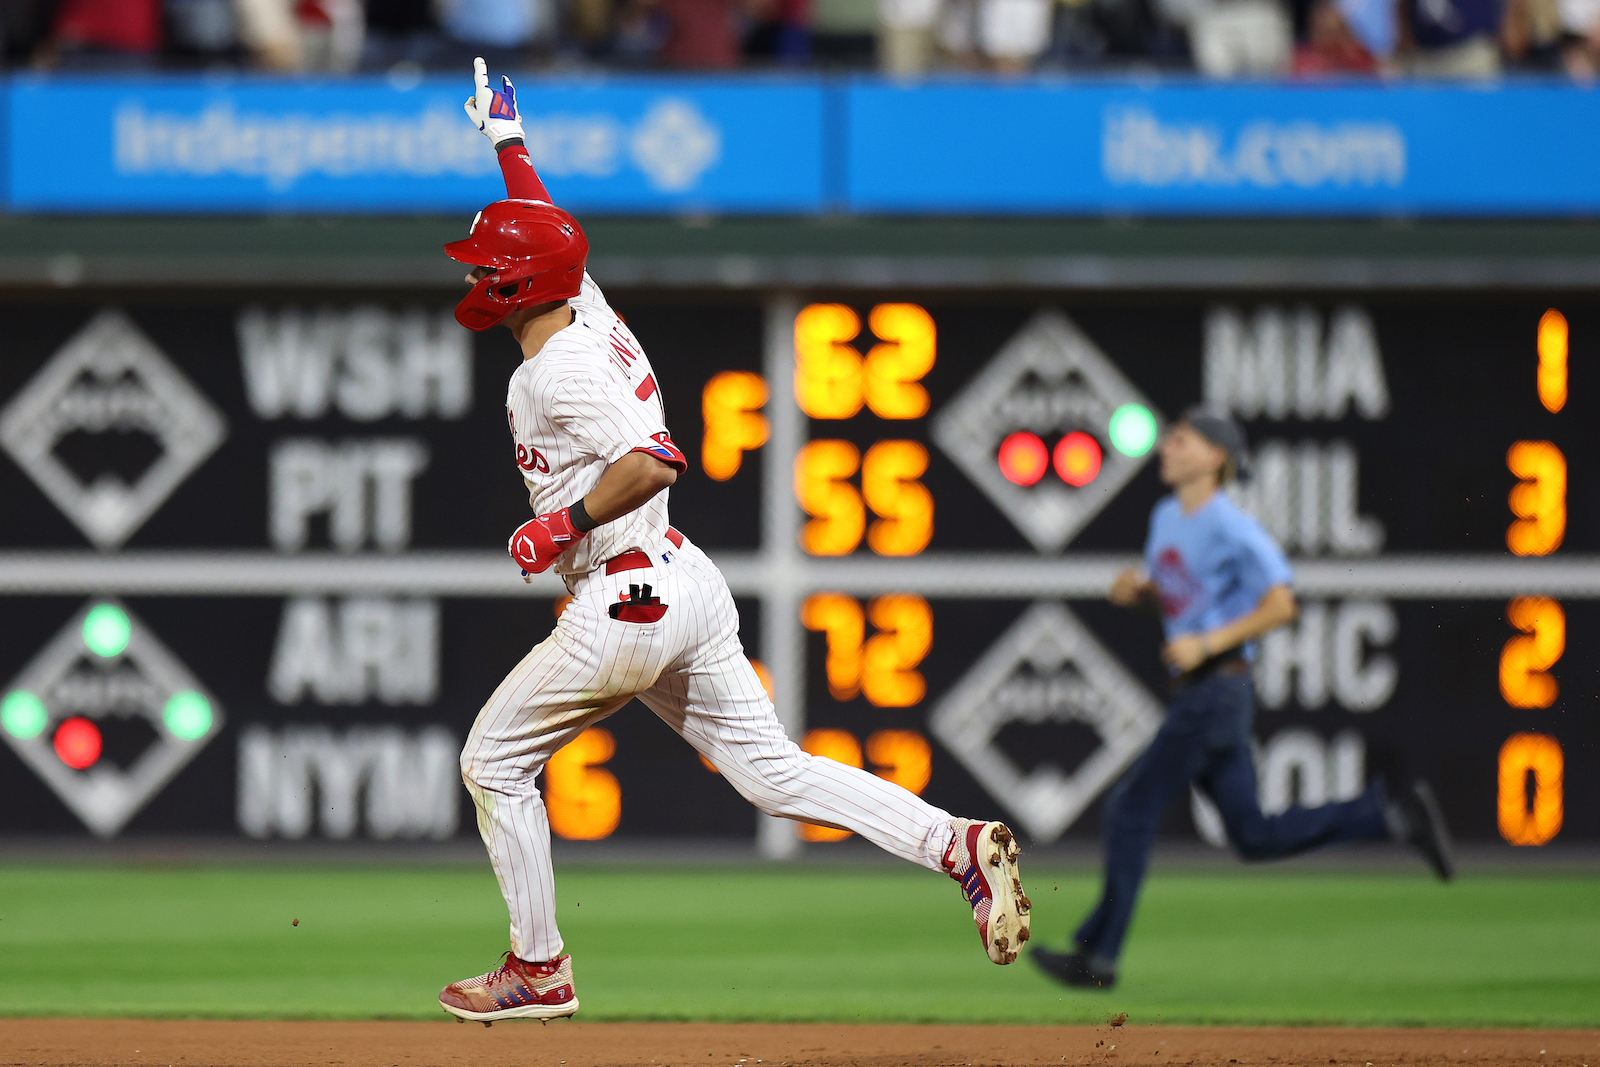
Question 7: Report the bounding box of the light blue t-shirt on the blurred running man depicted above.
[1144,493,1294,659]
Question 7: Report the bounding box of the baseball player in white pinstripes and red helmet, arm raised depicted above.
[438,59,1029,1022]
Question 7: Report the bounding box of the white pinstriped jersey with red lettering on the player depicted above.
[506,274,683,574]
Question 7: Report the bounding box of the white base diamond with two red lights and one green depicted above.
[933,310,1160,552]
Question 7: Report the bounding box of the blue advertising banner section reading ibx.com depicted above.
[845,82,1600,216]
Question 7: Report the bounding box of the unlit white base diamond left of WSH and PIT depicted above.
[0,303,227,549]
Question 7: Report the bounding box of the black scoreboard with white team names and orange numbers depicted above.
[0,287,1600,856]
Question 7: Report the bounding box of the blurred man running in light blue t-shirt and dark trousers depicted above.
[1032,408,1451,989]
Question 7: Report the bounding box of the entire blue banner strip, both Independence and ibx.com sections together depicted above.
[0,77,1600,216]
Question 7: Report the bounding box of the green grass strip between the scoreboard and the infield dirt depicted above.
[0,865,1600,1027]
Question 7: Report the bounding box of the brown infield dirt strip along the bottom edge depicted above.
[0,1019,1600,1067]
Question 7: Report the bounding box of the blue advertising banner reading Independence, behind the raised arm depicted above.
[6,78,822,214]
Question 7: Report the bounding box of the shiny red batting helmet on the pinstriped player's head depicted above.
[445,200,589,330]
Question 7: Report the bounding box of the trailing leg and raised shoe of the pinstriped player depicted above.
[640,542,1029,963]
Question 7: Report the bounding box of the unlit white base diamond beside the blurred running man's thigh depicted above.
[928,603,1163,841]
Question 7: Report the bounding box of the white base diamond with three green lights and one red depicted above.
[0,600,222,837]
